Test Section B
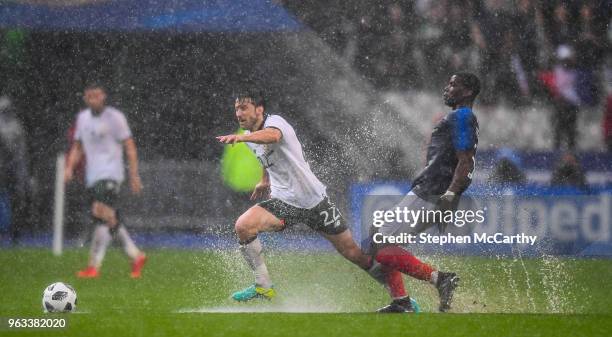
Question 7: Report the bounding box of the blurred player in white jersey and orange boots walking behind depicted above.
[64,84,146,278]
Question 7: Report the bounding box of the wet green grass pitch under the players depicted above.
[0,249,612,337]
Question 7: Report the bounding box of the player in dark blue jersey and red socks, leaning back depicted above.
[372,73,480,312]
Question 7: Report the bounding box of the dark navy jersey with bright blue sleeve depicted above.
[412,108,478,200]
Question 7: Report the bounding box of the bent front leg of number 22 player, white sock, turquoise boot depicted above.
[232,205,284,301]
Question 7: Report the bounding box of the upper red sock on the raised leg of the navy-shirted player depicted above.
[376,246,435,281]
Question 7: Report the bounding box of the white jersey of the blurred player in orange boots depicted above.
[75,106,132,187]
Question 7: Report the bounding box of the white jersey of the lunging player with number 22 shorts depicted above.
[247,115,326,209]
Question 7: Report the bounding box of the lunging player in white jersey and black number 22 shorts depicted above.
[217,89,403,301]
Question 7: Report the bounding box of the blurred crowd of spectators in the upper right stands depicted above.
[284,0,612,150]
